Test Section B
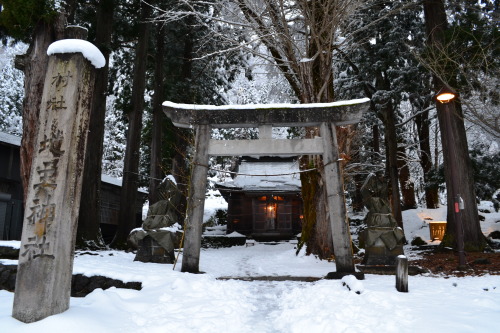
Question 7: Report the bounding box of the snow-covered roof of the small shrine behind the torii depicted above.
[217,160,301,192]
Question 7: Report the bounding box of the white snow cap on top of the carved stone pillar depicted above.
[47,39,106,68]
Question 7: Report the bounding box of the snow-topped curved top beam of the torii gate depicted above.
[163,98,369,128]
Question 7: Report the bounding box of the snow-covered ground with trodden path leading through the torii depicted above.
[0,204,500,333]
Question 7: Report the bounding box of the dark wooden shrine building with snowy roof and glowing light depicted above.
[217,157,303,240]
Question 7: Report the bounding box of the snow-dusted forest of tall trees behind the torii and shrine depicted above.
[0,0,500,258]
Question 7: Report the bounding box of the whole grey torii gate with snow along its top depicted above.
[163,98,369,274]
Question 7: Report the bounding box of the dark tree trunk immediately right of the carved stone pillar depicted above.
[76,0,115,249]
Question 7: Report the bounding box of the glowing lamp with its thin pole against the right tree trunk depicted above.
[435,86,465,267]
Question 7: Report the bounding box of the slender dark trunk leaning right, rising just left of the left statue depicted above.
[111,2,151,249]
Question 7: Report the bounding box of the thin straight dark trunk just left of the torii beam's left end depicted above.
[149,24,165,205]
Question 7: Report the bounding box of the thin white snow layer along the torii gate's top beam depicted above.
[163,98,370,110]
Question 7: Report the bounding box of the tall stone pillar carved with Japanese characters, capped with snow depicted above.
[12,33,105,323]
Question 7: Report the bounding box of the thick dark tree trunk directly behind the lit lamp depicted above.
[424,0,486,251]
